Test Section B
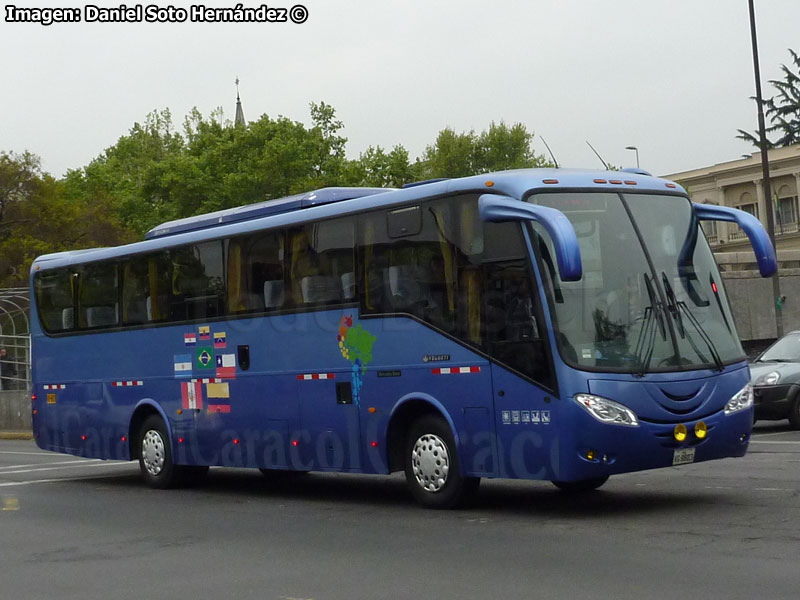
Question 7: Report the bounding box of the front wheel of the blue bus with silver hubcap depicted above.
[403,415,481,508]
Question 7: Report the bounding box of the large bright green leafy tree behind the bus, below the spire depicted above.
[68,102,354,235]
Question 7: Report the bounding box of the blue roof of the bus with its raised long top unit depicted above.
[31,169,686,271]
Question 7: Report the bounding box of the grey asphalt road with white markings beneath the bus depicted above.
[0,422,800,600]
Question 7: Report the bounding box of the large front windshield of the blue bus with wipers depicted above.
[528,192,744,375]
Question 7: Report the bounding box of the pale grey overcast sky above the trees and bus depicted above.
[0,0,800,176]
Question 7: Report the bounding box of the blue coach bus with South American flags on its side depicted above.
[30,169,777,508]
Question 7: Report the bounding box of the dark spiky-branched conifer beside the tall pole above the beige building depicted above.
[736,48,800,148]
